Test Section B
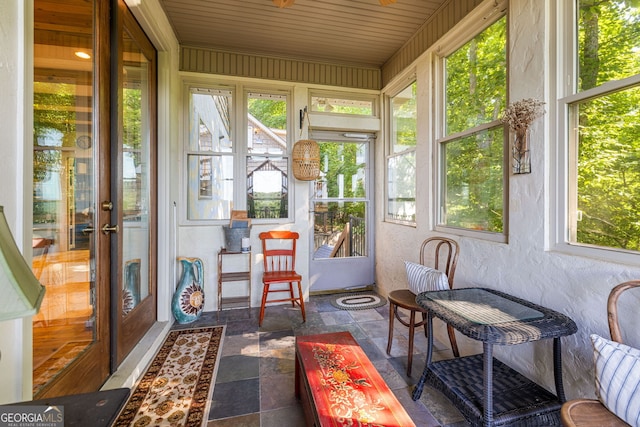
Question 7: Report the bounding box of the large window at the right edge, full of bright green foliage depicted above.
[557,0,640,256]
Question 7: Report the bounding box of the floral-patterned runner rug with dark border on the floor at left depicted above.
[112,326,225,427]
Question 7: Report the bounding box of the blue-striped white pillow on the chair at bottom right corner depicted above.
[591,334,640,427]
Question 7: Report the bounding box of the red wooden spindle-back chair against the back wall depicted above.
[258,231,307,326]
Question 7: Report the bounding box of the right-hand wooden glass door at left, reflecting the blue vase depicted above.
[111,1,157,370]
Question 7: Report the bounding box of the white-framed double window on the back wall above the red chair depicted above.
[186,86,291,221]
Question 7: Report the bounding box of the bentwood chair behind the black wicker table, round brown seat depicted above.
[387,237,460,376]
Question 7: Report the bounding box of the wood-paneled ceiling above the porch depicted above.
[160,0,455,68]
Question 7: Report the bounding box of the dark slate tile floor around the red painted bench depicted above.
[178,295,467,427]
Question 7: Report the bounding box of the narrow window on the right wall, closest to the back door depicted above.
[386,82,417,222]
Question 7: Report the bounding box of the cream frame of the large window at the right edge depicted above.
[548,0,640,264]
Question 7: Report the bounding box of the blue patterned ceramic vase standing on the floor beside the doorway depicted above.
[171,257,204,323]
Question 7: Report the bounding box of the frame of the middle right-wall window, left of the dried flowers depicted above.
[431,10,510,243]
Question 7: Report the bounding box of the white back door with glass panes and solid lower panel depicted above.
[309,134,374,292]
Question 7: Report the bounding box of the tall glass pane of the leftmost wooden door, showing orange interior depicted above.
[32,0,97,395]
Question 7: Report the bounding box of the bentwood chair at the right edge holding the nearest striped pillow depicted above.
[560,280,640,427]
